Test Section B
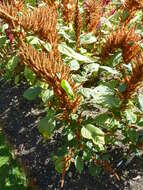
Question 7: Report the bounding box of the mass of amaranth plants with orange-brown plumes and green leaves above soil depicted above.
[0,0,143,187]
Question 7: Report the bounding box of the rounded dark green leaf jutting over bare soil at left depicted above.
[23,87,41,101]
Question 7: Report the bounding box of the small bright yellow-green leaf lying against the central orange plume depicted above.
[61,79,74,100]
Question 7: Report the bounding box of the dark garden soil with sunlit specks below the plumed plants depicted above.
[0,79,143,190]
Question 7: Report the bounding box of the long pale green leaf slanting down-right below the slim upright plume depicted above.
[59,43,95,63]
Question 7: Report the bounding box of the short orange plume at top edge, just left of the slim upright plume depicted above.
[61,0,76,23]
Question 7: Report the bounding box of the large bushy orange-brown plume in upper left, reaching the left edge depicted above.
[0,4,58,47]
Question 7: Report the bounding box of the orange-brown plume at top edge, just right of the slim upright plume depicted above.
[83,0,103,32]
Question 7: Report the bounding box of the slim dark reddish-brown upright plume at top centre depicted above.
[74,0,82,49]
